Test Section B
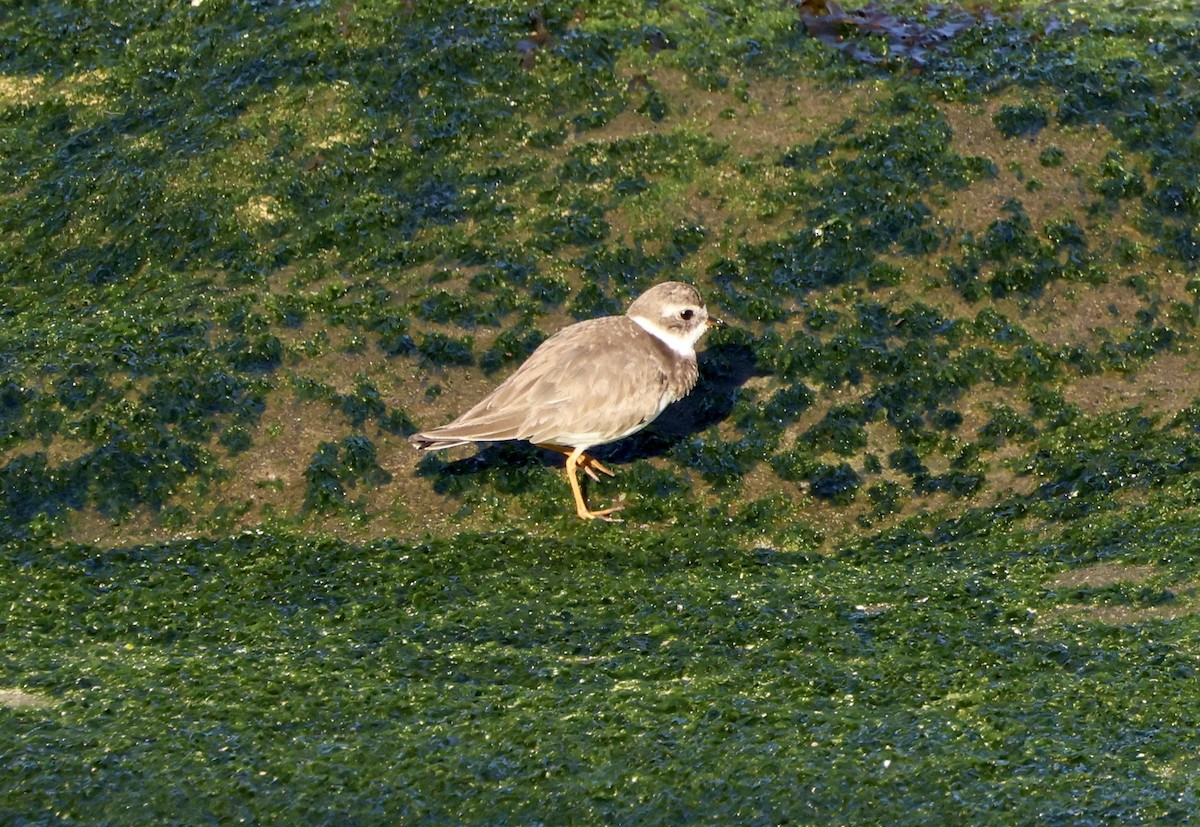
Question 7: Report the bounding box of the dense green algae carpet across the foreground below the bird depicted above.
[4,518,1200,823]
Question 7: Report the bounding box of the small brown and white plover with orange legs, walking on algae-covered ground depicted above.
[409,281,724,522]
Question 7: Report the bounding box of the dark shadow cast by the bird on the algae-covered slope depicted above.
[416,343,757,491]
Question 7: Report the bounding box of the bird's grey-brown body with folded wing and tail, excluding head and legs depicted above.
[412,317,696,449]
